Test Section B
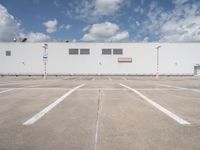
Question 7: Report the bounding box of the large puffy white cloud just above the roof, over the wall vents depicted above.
[81,22,129,42]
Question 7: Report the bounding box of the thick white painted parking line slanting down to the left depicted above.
[23,84,85,126]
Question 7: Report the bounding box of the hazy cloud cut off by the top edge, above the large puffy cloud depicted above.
[63,0,126,22]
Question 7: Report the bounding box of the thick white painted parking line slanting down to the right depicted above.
[120,84,190,125]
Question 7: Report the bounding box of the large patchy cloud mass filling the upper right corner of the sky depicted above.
[138,0,200,42]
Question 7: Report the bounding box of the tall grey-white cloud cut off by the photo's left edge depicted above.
[0,4,21,41]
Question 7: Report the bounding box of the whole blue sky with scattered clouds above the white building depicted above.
[0,0,200,42]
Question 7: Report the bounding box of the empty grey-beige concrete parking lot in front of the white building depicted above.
[0,76,200,150]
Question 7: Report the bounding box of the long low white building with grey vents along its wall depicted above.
[0,43,200,75]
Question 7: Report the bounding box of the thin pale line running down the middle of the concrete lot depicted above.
[94,89,102,150]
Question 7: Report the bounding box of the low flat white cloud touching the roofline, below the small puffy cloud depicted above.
[20,32,51,42]
